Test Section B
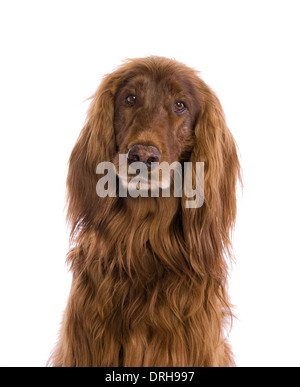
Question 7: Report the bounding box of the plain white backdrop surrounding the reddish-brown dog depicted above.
[0,0,300,366]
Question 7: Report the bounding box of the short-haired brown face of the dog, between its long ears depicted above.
[114,69,199,188]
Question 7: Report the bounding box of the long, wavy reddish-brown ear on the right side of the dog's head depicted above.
[182,78,240,281]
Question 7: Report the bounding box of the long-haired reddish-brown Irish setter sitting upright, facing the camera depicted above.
[50,57,240,367]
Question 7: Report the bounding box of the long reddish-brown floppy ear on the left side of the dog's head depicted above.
[67,75,118,236]
